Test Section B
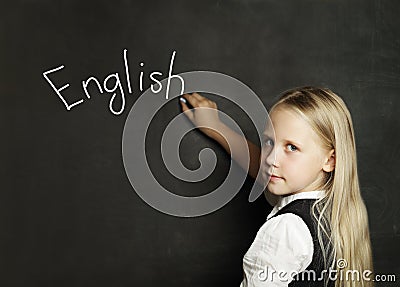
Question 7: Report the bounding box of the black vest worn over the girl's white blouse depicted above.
[270,199,335,287]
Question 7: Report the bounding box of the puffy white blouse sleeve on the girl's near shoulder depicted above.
[240,213,314,287]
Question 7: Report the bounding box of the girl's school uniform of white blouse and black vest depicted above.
[240,190,333,287]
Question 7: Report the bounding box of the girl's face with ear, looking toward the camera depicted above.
[261,107,334,195]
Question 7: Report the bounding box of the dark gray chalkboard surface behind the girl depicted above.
[0,0,400,287]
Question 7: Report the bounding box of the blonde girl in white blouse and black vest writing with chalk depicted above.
[181,87,373,287]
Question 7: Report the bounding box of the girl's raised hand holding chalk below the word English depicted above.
[179,93,222,137]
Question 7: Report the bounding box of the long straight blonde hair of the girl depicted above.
[271,87,373,287]
